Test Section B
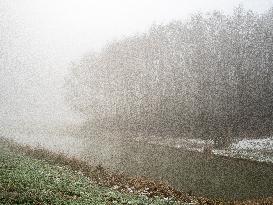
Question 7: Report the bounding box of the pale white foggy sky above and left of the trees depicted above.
[0,0,273,125]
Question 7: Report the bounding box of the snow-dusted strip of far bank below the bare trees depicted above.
[135,136,273,163]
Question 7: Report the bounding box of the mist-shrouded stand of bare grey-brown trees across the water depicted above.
[66,8,273,145]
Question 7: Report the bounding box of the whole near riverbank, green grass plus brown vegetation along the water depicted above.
[0,137,273,205]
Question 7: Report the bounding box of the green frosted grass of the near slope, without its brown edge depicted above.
[0,142,174,204]
